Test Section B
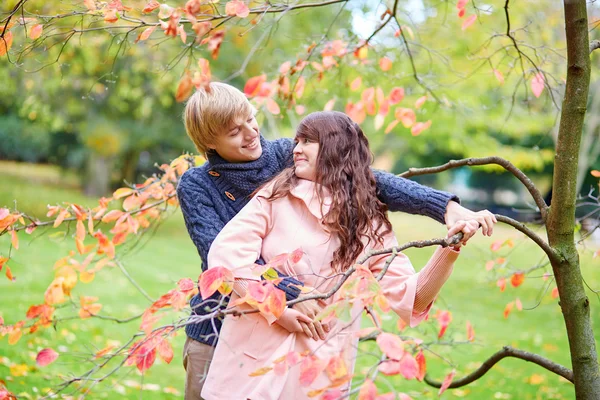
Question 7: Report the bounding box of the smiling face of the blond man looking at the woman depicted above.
[208,111,262,163]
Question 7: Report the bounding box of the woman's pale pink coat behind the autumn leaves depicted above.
[202,180,457,400]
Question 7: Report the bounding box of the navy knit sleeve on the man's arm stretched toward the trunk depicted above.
[373,169,460,224]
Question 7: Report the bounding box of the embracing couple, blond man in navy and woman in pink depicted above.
[177,83,495,399]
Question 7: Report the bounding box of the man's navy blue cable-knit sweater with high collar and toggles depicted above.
[177,137,458,346]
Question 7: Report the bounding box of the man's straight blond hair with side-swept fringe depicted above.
[183,82,255,154]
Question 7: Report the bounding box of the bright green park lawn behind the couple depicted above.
[0,161,600,400]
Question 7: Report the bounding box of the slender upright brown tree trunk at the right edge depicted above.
[547,0,600,399]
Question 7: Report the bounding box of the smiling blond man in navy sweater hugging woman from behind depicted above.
[177,83,496,399]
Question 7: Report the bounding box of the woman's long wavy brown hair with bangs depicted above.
[268,111,392,271]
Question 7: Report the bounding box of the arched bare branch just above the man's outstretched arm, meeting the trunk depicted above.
[398,156,548,222]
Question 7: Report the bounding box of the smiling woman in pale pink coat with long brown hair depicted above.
[202,112,465,400]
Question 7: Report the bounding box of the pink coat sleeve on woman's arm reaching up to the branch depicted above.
[369,232,458,327]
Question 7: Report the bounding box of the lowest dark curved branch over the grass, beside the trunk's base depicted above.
[425,346,573,389]
